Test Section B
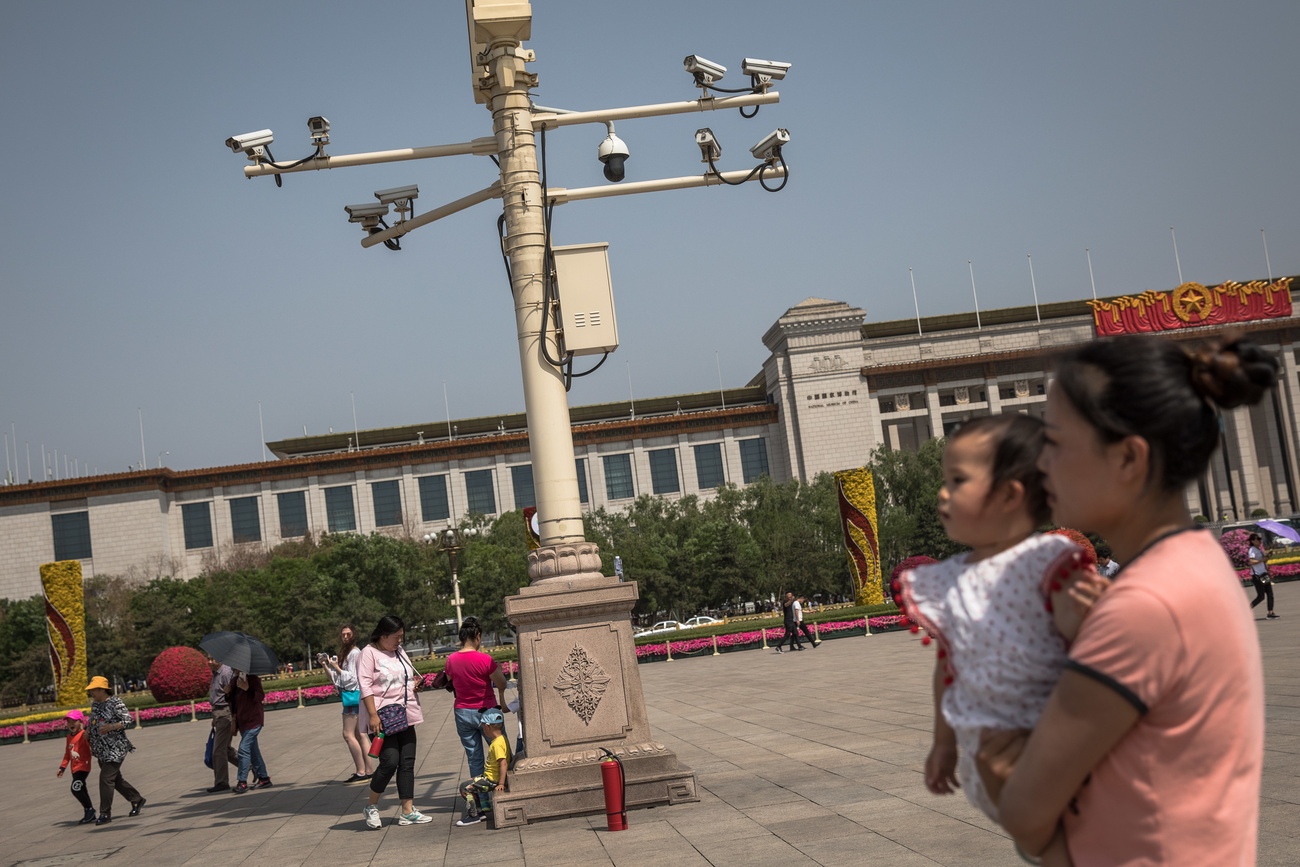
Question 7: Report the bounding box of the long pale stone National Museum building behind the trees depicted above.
[0,278,1300,598]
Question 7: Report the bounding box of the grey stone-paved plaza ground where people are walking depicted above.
[0,584,1300,867]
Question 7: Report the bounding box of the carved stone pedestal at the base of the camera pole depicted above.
[493,542,699,828]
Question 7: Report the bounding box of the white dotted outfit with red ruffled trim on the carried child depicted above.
[896,536,1080,820]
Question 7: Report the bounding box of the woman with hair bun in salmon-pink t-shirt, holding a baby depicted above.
[978,335,1277,867]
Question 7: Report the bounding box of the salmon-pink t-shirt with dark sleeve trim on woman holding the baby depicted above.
[1063,530,1264,867]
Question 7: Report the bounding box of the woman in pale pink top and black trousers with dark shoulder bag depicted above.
[356,615,433,829]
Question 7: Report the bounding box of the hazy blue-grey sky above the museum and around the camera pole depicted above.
[0,0,1300,478]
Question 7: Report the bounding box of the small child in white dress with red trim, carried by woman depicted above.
[894,413,1105,820]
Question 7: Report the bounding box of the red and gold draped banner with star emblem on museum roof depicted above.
[1088,277,1291,337]
